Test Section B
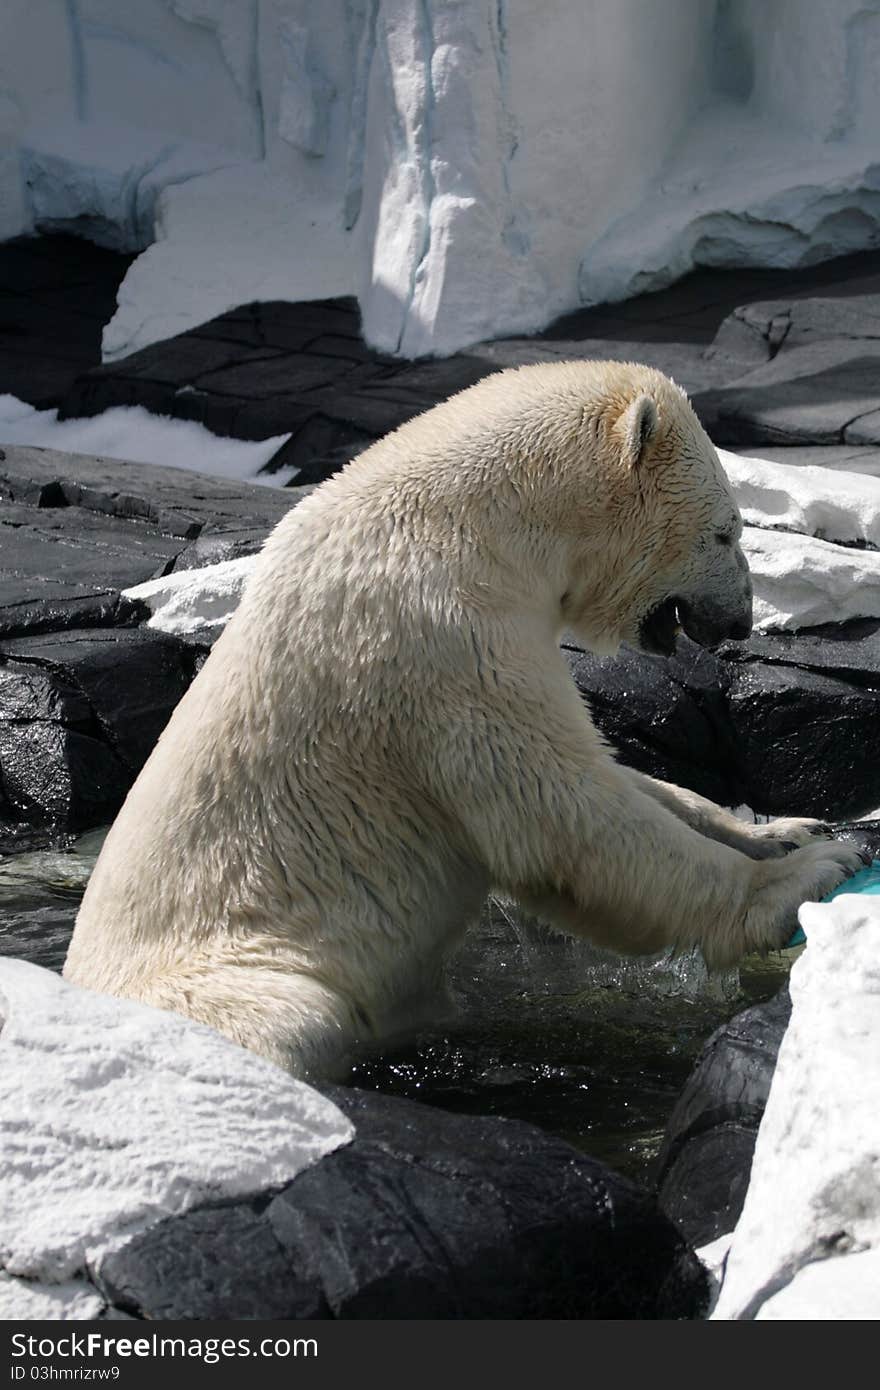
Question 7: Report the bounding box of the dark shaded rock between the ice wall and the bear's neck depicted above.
[60,297,492,482]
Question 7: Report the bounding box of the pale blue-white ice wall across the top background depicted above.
[0,0,880,357]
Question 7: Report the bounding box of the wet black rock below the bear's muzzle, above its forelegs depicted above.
[566,620,880,820]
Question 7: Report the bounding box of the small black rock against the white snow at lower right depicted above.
[656,984,791,1245]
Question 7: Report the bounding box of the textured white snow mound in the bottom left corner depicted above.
[0,960,353,1316]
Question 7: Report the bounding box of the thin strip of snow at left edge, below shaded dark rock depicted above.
[0,395,296,488]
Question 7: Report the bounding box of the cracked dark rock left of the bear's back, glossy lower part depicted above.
[0,446,302,852]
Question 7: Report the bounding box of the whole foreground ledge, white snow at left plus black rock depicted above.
[0,960,709,1319]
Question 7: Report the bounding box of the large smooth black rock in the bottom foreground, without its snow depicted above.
[93,1088,706,1319]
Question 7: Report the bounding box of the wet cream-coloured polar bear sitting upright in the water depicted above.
[64,361,861,1077]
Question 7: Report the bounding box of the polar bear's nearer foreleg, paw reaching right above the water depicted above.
[450,709,862,966]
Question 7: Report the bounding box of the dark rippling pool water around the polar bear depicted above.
[0,831,794,1182]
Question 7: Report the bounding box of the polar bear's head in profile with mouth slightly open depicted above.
[525,361,752,656]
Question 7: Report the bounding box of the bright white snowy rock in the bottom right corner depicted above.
[713,897,880,1321]
